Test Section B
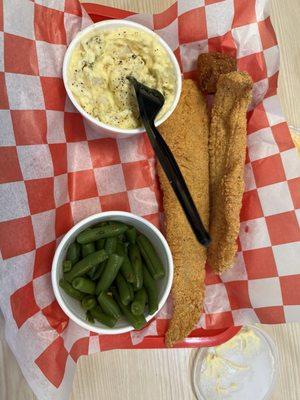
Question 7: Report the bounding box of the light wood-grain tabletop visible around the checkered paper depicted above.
[0,0,300,400]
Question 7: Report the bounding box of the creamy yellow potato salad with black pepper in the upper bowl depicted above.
[68,28,176,129]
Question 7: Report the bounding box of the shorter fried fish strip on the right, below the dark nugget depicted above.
[208,72,252,272]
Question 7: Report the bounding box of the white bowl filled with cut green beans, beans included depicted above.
[52,211,173,334]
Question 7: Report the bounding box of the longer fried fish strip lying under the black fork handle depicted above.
[158,80,209,347]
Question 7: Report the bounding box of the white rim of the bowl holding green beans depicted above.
[51,211,174,335]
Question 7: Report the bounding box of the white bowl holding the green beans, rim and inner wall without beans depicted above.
[51,211,173,335]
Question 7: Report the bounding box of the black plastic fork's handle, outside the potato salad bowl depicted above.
[143,118,211,247]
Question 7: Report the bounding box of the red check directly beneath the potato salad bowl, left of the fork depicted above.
[89,138,120,168]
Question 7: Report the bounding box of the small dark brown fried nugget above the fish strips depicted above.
[197,52,236,94]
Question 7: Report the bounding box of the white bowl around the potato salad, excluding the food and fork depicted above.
[63,19,182,138]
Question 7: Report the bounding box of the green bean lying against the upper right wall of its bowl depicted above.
[137,235,165,280]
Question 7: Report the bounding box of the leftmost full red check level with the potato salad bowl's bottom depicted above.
[10,110,47,146]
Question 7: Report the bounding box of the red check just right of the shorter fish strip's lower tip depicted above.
[243,247,278,279]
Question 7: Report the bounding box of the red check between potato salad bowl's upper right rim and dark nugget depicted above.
[178,7,207,44]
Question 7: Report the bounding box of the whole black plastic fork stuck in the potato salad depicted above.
[127,76,211,246]
